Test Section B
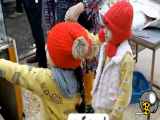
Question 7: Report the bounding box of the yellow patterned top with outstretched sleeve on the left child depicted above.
[0,59,80,120]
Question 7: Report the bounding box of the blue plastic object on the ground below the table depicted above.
[131,71,152,104]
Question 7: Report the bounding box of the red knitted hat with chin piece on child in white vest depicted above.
[103,1,133,57]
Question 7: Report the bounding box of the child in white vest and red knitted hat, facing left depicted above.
[92,1,134,120]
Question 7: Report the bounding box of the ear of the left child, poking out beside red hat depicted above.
[72,36,89,59]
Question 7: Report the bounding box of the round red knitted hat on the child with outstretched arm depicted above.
[47,22,91,69]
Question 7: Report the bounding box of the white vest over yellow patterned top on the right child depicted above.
[92,41,134,120]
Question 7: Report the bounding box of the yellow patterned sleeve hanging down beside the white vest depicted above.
[111,53,134,120]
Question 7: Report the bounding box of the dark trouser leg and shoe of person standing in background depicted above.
[23,0,47,68]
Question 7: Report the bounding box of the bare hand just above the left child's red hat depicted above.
[65,2,84,22]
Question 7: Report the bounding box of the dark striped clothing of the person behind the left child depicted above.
[43,0,104,31]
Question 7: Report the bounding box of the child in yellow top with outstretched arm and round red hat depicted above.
[0,22,99,120]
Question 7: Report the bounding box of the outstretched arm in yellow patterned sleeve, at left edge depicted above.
[0,59,47,94]
